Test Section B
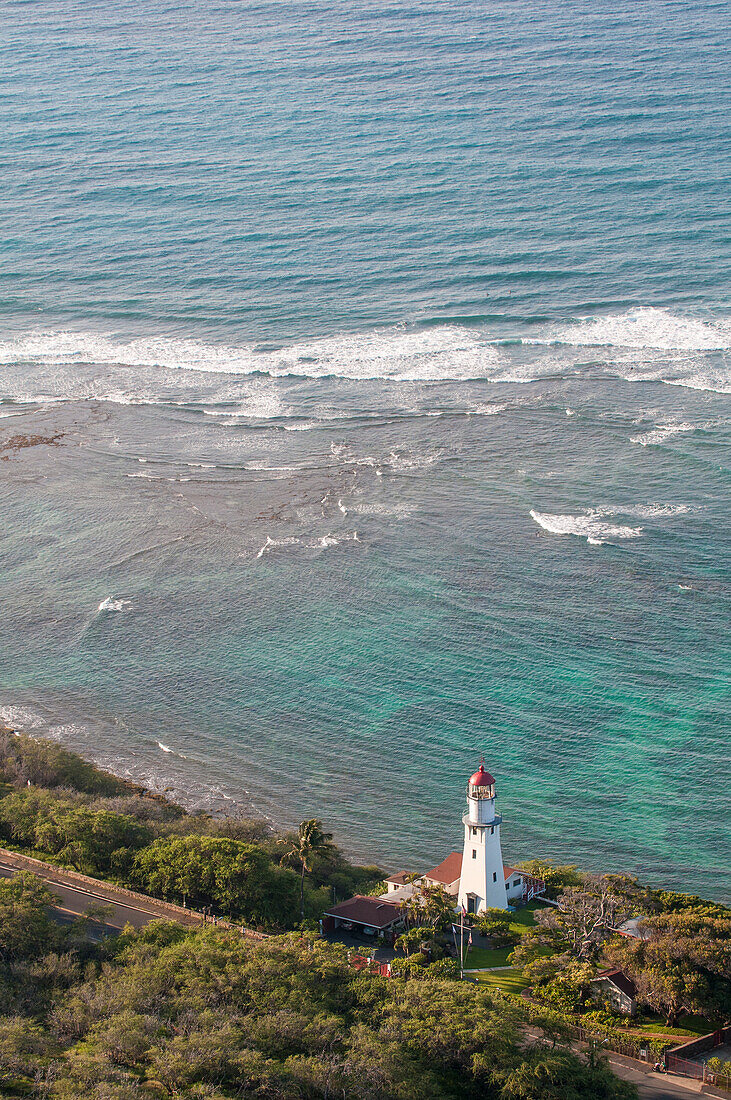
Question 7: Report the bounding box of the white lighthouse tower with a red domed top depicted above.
[459,763,508,913]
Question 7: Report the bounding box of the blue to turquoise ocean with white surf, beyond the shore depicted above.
[0,0,731,897]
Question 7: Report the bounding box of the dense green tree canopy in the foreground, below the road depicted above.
[0,879,635,1100]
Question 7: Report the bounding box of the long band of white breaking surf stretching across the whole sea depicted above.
[0,307,731,402]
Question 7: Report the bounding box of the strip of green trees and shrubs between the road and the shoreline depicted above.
[0,729,383,932]
